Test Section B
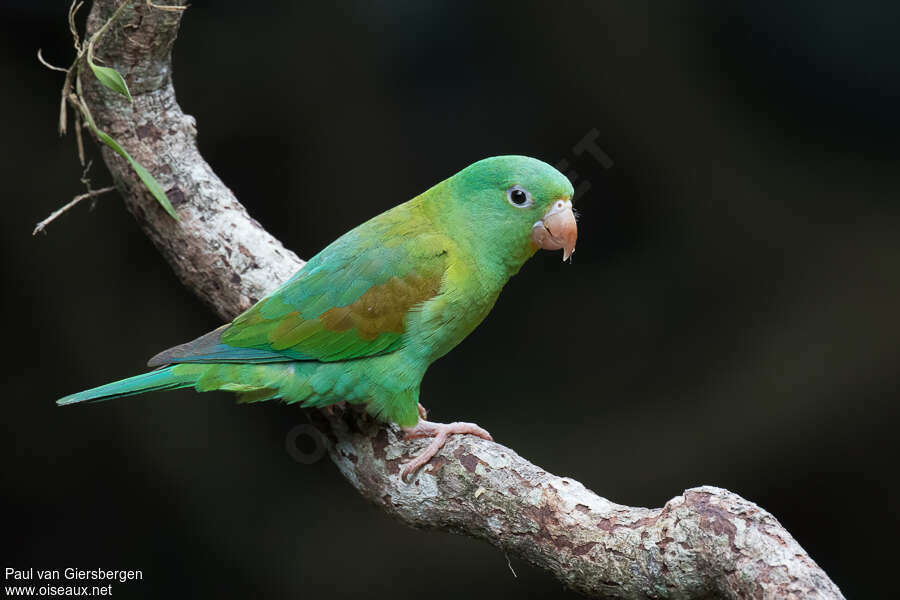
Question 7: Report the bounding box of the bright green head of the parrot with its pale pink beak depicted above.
[443,156,578,264]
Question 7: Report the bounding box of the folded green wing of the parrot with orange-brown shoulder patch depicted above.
[148,213,454,366]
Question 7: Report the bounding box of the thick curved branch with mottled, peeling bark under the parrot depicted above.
[75,0,843,599]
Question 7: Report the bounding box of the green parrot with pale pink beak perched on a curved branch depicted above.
[57,156,577,477]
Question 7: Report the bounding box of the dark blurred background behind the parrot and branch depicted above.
[0,0,900,598]
